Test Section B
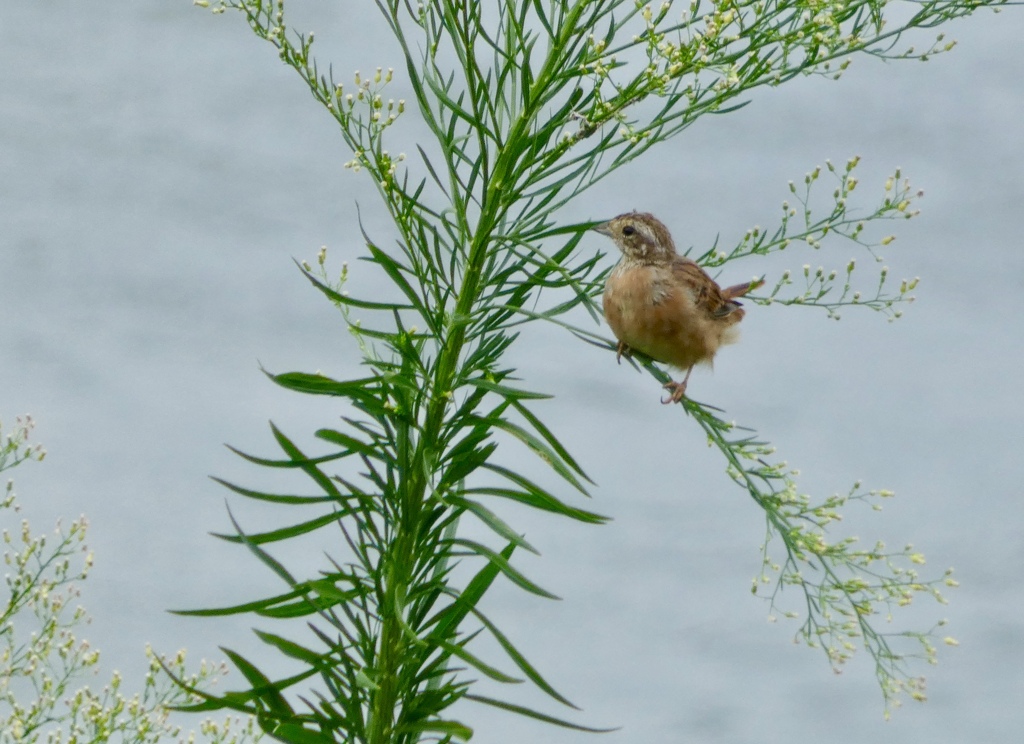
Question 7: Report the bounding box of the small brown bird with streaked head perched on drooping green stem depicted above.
[594,212,764,403]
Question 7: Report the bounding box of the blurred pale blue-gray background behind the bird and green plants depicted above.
[0,0,1024,744]
